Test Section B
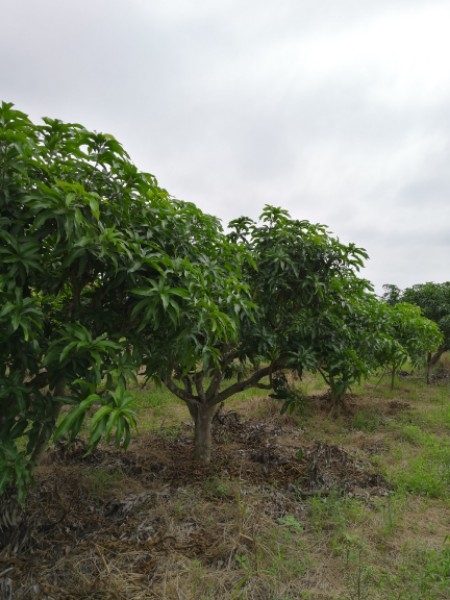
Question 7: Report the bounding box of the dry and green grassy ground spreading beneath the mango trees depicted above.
[9,358,450,600]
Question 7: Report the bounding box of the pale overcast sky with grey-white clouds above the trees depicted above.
[0,0,450,292]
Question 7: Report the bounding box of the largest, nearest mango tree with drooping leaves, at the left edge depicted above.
[0,103,241,545]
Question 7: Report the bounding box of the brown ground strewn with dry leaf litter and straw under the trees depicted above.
[0,402,402,600]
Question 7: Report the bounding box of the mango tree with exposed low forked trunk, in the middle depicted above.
[140,206,376,462]
